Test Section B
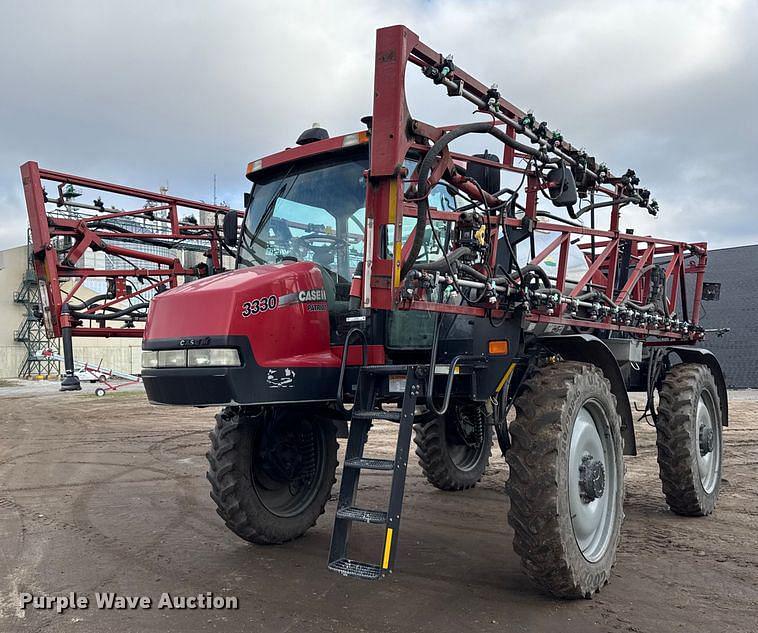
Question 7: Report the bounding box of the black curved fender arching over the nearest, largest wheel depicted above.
[539,334,640,455]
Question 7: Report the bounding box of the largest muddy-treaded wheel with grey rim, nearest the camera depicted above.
[505,362,624,598]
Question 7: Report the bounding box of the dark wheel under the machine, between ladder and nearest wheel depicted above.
[413,402,492,490]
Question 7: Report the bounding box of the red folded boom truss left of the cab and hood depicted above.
[21,161,242,338]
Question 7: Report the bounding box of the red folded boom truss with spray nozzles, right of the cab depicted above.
[361,26,707,344]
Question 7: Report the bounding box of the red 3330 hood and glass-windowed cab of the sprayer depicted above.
[143,138,376,405]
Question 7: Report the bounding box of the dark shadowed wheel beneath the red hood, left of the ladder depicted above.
[206,408,337,544]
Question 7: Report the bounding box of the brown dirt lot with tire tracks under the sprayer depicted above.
[0,385,758,633]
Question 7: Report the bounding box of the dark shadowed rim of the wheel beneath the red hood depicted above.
[250,421,326,518]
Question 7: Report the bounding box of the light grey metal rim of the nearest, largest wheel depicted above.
[568,400,619,562]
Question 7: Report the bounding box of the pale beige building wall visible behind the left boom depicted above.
[0,246,142,378]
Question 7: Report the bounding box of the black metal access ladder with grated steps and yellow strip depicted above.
[329,365,428,580]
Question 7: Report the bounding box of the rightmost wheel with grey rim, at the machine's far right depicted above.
[656,363,723,516]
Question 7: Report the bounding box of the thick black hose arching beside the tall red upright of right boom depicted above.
[400,121,547,277]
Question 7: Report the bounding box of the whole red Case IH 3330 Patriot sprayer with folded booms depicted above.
[20,26,727,597]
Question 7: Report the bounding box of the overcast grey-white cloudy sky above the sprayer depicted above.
[0,0,758,248]
